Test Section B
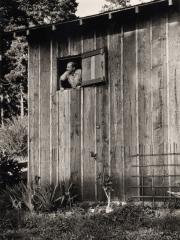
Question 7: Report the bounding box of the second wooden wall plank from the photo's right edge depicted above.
[152,15,168,196]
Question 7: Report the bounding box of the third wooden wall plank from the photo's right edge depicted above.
[137,16,153,196]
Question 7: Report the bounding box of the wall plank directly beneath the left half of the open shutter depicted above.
[82,34,96,200]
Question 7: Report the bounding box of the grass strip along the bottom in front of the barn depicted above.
[7,205,180,240]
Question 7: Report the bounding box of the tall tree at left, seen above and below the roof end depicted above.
[0,0,78,124]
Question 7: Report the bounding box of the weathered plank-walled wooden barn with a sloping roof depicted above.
[17,0,180,201]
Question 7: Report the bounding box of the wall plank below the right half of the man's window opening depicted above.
[70,32,81,199]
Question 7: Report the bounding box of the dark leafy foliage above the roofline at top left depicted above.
[0,0,78,30]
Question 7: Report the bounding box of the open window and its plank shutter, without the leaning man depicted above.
[57,48,107,89]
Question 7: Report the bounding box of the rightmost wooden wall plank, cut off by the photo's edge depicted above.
[168,9,180,191]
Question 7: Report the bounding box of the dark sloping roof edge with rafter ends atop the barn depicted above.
[8,0,176,36]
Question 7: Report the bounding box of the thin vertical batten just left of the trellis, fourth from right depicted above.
[121,25,126,201]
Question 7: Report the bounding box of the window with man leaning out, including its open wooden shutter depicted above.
[57,48,107,90]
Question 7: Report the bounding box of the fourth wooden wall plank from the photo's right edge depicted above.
[123,21,138,198]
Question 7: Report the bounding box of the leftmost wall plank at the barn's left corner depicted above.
[28,42,40,183]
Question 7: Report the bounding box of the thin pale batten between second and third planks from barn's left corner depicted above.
[49,40,53,184]
